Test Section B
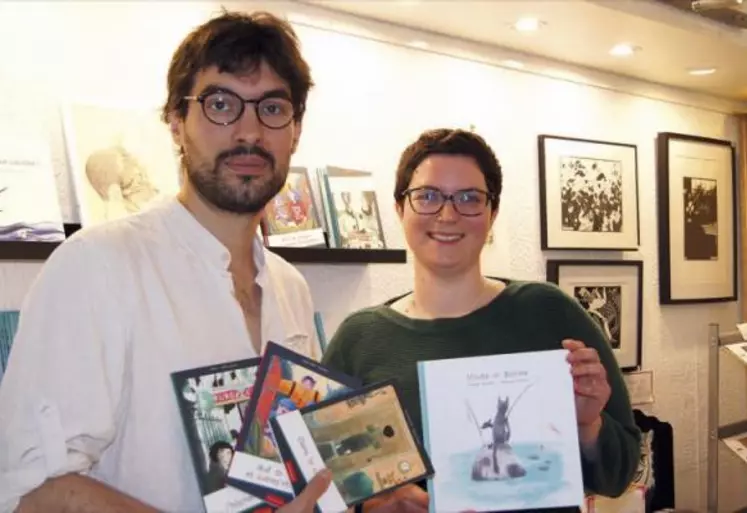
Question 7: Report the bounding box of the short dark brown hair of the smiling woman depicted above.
[394,128,503,211]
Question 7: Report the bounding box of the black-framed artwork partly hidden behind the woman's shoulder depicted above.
[547,260,643,372]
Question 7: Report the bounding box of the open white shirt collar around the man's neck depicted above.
[164,196,267,278]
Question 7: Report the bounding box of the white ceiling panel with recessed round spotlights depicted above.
[301,0,747,105]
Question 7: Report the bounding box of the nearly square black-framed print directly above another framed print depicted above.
[538,135,640,251]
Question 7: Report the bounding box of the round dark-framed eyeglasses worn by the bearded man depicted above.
[184,89,295,129]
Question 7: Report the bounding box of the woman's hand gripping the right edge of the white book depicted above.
[563,339,612,445]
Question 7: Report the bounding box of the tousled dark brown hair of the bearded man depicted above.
[162,11,314,121]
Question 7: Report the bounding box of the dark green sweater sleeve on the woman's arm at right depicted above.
[553,288,641,497]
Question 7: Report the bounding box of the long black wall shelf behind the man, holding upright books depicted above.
[0,223,407,264]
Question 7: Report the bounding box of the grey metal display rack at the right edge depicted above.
[706,323,747,513]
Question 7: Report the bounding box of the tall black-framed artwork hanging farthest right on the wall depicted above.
[657,132,737,304]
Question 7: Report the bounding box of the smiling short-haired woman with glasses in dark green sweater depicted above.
[323,129,640,511]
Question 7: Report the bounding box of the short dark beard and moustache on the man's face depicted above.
[182,136,289,214]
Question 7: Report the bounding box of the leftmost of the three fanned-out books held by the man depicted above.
[171,358,267,513]
